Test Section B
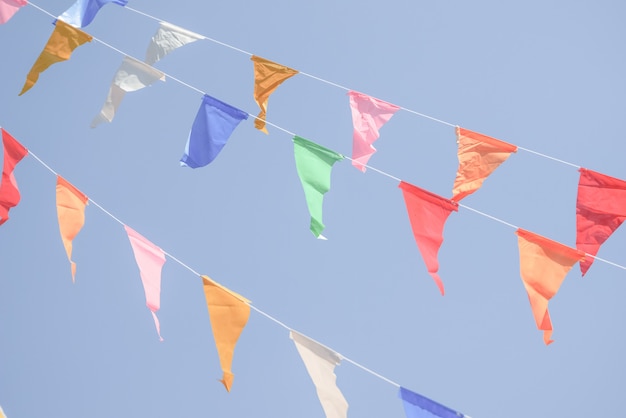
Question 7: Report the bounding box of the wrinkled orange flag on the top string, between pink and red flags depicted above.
[452,126,517,202]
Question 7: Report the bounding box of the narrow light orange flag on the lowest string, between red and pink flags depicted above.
[57,175,89,282]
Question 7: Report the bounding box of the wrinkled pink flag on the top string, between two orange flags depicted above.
[348,91,400,172]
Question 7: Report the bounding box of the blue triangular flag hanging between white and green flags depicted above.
[180,94,248,168]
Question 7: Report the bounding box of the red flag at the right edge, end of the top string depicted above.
[576,168,626,276]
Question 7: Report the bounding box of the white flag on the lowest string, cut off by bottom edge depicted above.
[289,331,348,418]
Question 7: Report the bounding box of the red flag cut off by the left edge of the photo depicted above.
[0,129,28,225]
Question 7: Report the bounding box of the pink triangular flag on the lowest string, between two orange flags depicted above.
[124,225,165,341]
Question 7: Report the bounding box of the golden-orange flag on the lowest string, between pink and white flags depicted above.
[202,276,250,392]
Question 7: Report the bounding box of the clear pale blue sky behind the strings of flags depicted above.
[0,0,626,418]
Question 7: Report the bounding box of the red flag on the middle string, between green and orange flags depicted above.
[399,181,459,295]
